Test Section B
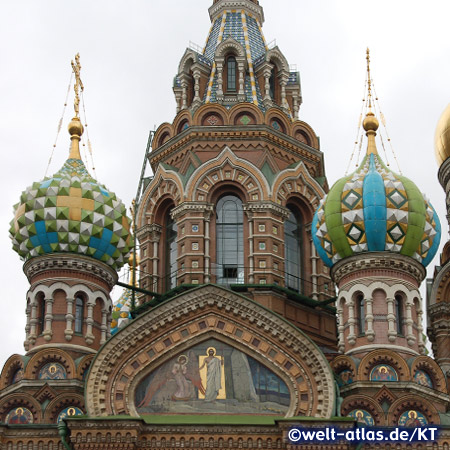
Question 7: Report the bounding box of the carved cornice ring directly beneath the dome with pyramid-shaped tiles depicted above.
[23,253,118,289]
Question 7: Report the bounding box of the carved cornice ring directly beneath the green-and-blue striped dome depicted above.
[331,252,426,285]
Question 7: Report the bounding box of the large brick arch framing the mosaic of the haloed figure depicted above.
[86,285,335,418]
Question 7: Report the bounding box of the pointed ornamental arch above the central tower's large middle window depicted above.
[186,147,270,201]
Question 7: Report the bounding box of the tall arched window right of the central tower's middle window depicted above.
[284,206,302,292]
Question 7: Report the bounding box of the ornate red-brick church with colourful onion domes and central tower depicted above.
[0,0,450,450]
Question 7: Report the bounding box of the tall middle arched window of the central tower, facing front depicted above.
[216,195,244,284]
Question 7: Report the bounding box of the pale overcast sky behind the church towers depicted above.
[0,0,450,366]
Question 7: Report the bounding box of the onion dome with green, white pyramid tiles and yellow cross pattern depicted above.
[10,119,132,270]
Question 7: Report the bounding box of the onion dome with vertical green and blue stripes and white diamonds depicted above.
[312,112,441,267]
